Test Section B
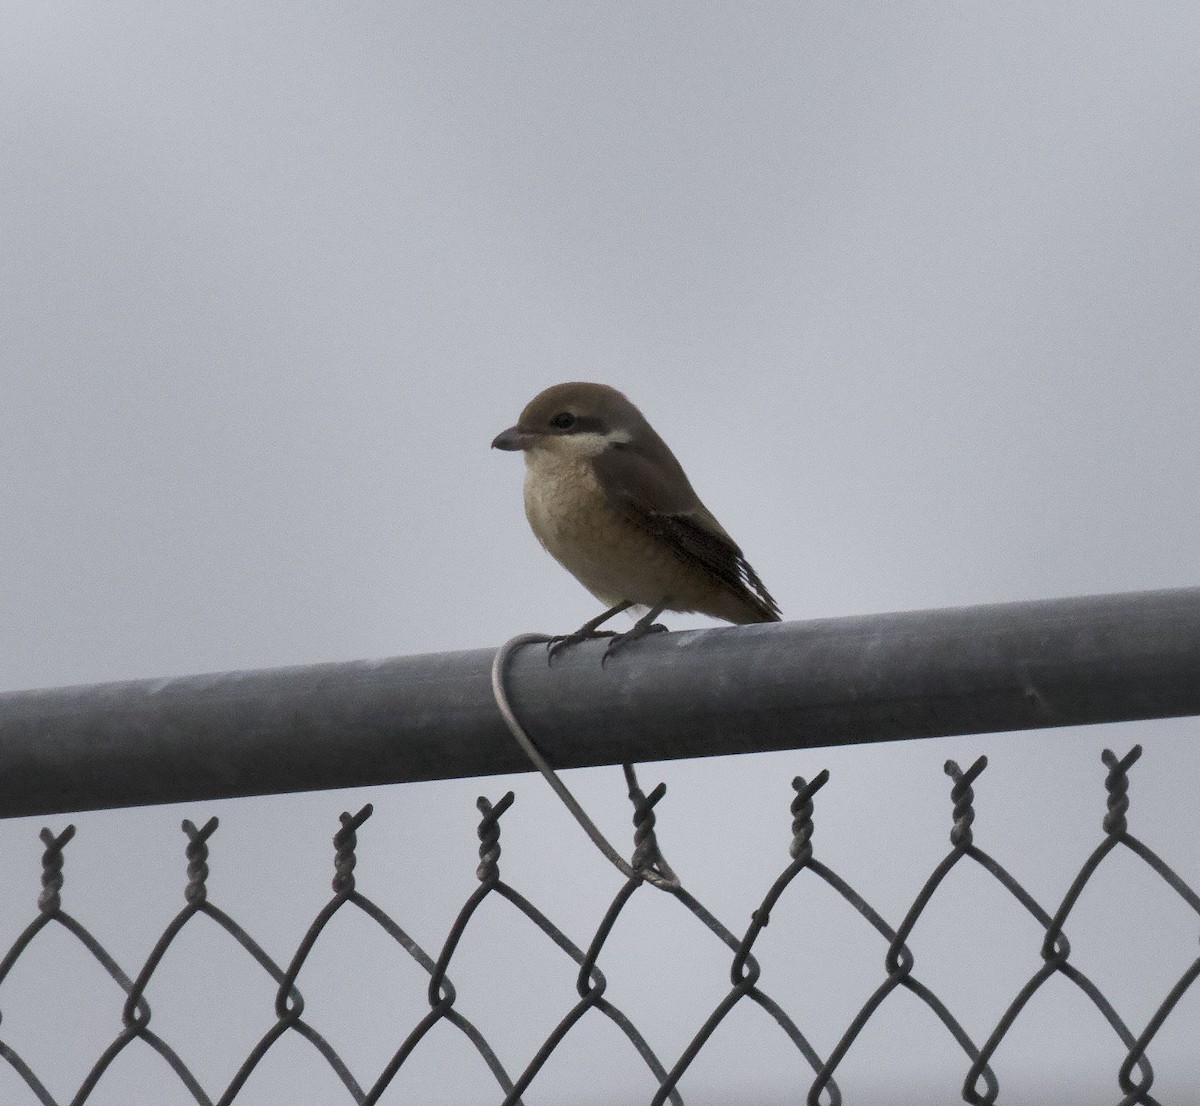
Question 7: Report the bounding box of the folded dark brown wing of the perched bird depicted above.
[593,446,780,623]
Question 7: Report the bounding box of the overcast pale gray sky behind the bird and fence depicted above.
[0,0,1200,1106]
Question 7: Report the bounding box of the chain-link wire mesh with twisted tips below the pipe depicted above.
[0,746,1200,1106]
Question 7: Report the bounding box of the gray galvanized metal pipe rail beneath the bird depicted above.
[0,588,1200,817]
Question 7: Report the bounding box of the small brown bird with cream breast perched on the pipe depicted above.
[492,380,780,663]
